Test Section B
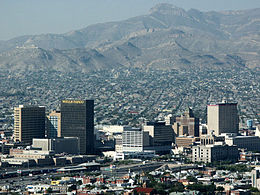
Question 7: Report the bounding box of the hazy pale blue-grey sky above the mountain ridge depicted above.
[0,0,260,40]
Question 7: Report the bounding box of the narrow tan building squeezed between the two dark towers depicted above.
[46,110,61,138]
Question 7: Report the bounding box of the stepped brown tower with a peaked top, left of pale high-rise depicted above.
[173,108,199,137]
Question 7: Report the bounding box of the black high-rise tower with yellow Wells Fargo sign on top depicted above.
[61,100,94,154]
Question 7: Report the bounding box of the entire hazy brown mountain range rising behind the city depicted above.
[0,4,260,72]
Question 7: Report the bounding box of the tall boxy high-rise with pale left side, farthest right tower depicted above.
[208,101,239,136]
